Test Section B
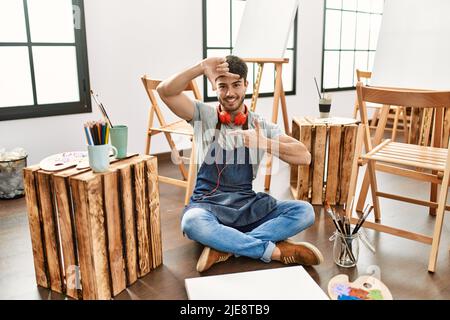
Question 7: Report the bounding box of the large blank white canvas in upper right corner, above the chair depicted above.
[371,0,450,90]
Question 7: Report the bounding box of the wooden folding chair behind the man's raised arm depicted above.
[141,75,202,205]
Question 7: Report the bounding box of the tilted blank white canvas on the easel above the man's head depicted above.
[233,0,298,58]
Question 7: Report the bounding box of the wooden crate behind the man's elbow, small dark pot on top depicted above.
[290,117,358,205]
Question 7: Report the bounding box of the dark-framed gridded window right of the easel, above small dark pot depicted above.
[322,0,384,92]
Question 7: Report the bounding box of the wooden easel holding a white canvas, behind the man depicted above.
[233,0,298,190]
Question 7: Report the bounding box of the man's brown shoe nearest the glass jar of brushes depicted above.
[277,240,323,266]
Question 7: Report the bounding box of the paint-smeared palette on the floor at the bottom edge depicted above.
[328,274,393,300]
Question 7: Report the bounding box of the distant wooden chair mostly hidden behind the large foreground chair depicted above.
[353,69,409,142]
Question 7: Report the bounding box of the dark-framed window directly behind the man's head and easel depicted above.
[203,0,298,101]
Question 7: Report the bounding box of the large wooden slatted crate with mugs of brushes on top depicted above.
[24,156,162,299]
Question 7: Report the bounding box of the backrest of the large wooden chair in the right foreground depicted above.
[356,82,450,151]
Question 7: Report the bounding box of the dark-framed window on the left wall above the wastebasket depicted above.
[0,0,91,120]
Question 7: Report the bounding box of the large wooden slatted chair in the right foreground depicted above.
[346,82,450,272]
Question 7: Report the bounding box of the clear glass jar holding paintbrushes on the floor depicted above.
[330,231,359,268]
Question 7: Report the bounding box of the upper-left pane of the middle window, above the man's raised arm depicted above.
[206,0,231,47]
